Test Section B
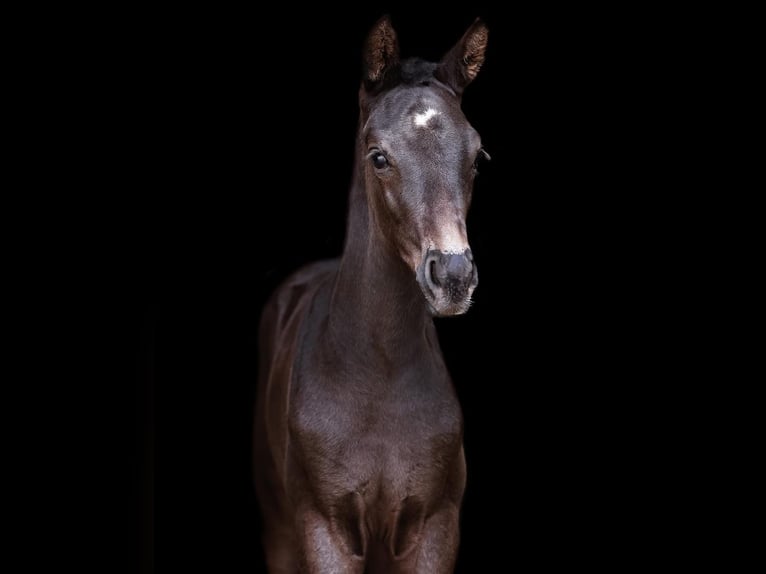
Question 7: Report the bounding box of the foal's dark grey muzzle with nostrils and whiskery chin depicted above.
[417,249,479,316]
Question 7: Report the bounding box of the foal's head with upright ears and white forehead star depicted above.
[358,17,489,316]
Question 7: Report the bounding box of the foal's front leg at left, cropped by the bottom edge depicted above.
[300,509,364,574]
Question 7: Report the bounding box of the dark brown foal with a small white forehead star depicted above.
[254,17,488,574]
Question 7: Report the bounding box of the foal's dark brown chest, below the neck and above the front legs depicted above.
[291,378,462,497]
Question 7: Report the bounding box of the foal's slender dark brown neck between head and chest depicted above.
[329,169,434,364]
